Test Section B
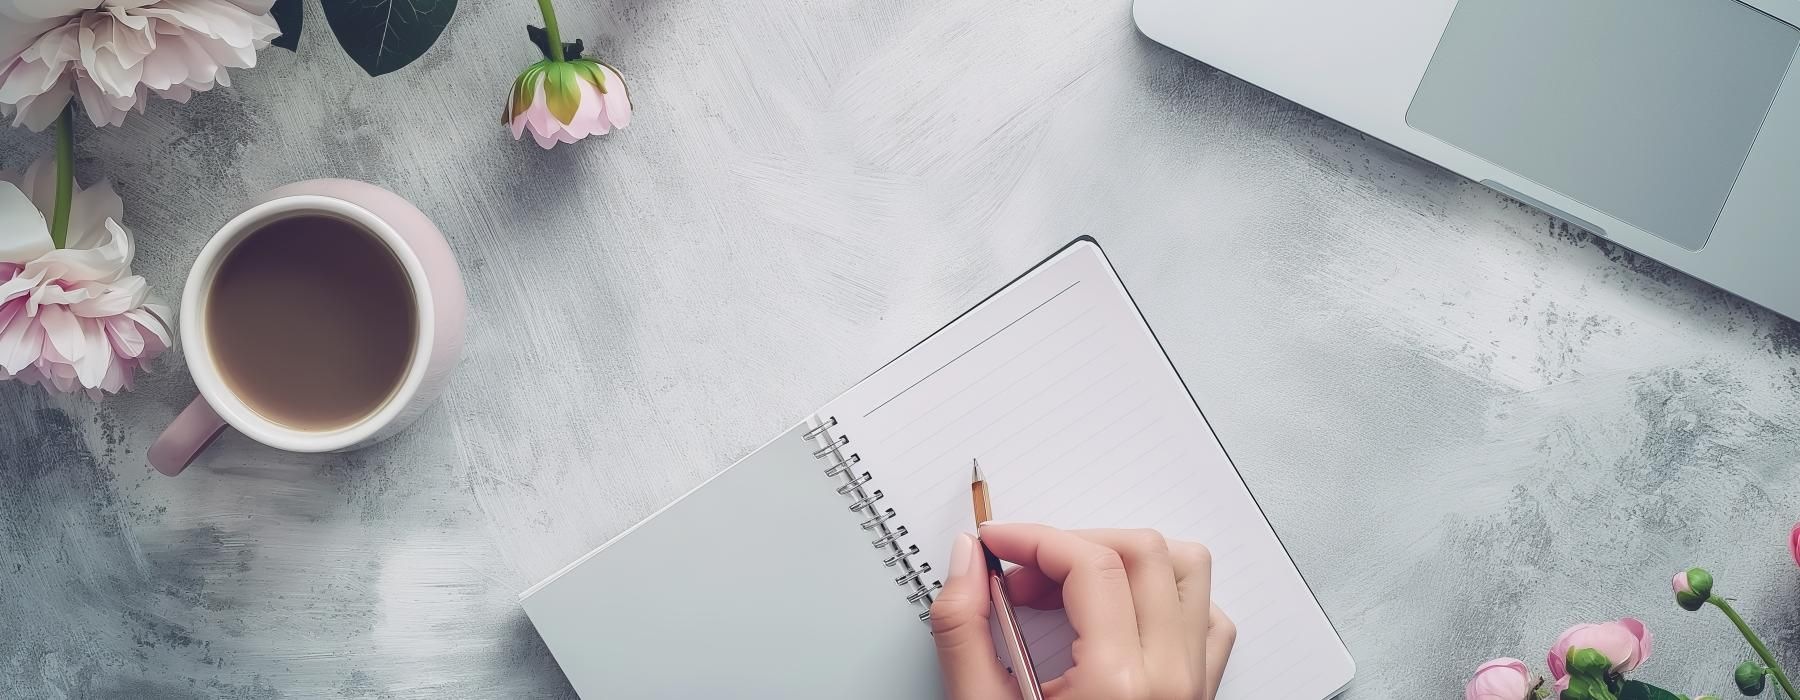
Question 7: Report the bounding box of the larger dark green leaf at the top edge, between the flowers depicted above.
[319,0,455,76]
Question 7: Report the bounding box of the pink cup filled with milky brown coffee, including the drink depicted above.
[149,180,466,477]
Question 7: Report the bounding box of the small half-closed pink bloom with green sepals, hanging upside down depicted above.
[500,58,632,148]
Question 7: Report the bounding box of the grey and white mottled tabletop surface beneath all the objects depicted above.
[0,0,1800,698]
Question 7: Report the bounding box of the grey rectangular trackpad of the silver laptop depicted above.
[1406,0,1800,250]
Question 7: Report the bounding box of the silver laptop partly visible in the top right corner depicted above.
[1134,0,1800,319]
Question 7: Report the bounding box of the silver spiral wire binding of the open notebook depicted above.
[803,416,943,621]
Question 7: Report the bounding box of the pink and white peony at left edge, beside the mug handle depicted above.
[0,158,173,398]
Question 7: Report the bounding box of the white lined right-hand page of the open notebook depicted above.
[819,241,1354,700]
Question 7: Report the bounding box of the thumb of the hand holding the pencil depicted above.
[931,534,1019,700]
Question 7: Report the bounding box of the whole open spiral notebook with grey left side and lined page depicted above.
[522,239,1354,700]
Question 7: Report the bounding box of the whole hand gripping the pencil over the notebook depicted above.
[931,524,1237,700]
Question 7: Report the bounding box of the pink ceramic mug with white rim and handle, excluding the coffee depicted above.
[149,180,464,477]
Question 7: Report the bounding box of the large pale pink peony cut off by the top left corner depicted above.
[0,0,281,131]
